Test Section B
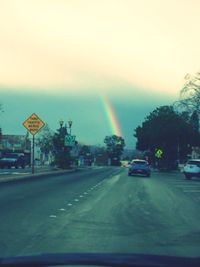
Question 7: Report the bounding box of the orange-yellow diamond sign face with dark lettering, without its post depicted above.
[23,113,45,135]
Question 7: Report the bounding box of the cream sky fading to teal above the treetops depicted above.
[0,0,200,148]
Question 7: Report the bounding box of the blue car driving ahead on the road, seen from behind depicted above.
[128,159,151,177]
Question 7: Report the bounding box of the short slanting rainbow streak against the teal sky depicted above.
[101,96,122,136]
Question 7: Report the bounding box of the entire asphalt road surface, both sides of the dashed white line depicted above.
[0,167,200,257]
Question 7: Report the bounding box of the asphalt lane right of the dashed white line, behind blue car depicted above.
[15,171,200,256]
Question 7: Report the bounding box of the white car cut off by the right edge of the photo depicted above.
[183,159,200,179]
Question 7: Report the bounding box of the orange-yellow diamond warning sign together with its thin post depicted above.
[23,113,45,174]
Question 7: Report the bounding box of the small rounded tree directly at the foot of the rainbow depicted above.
[104,135,125,165]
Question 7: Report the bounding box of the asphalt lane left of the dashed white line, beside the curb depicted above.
[0,168,119,256]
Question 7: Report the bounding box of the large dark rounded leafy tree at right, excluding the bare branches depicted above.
[134,106,198,168]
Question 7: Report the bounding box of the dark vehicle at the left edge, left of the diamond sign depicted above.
[0,153,25,169]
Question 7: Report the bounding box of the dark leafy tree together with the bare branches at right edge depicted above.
[133,73,200,169]
